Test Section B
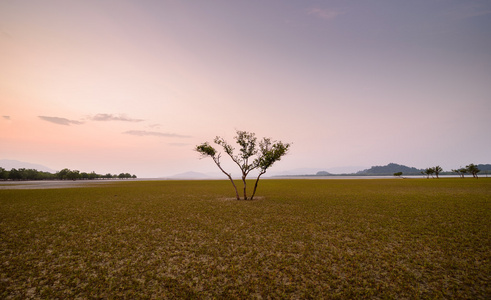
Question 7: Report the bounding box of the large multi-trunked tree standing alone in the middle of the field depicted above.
[195,130,291,200]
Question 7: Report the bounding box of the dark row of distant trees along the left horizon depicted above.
[0,167,136,180]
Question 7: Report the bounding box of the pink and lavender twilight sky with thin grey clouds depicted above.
[0,0,491,178]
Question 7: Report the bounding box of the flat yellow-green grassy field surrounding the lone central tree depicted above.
[0,178,491,299]
